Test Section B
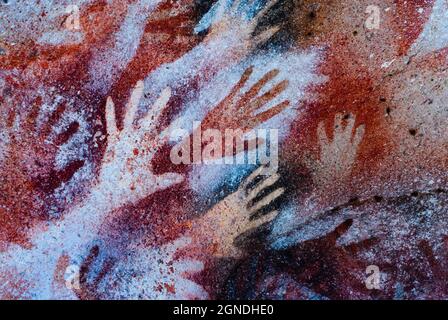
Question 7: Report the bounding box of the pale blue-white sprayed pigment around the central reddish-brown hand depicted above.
[176,51,324,194]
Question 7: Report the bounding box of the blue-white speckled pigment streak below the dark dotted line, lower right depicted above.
[269,194,448,252]
